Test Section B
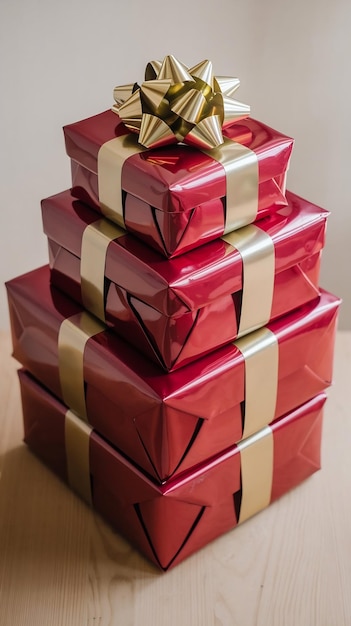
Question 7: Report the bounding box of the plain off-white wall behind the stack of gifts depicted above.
[0,0,351,328]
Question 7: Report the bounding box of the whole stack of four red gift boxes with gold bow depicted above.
[7,57,340,570]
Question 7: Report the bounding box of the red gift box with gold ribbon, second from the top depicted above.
[42,191,328,371]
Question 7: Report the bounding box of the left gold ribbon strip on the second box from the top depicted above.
[80,219,125,322]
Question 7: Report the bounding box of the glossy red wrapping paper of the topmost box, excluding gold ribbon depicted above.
[64,111,293,257]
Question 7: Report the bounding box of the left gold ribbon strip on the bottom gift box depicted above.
[65,410,92,505]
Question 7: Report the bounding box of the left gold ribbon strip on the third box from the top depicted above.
[58,312,106,421]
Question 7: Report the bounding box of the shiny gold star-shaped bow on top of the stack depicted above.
[112,55,250,149]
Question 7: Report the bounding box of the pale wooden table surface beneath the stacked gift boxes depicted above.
[0,332,351,626]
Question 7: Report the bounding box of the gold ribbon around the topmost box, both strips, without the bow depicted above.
[97,134,258,233]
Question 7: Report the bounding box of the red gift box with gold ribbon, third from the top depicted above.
[7,267,340,481]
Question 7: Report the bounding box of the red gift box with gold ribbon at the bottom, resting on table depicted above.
[20,372,325,570]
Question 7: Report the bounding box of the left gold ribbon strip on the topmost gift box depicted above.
[98,134,145,228]
